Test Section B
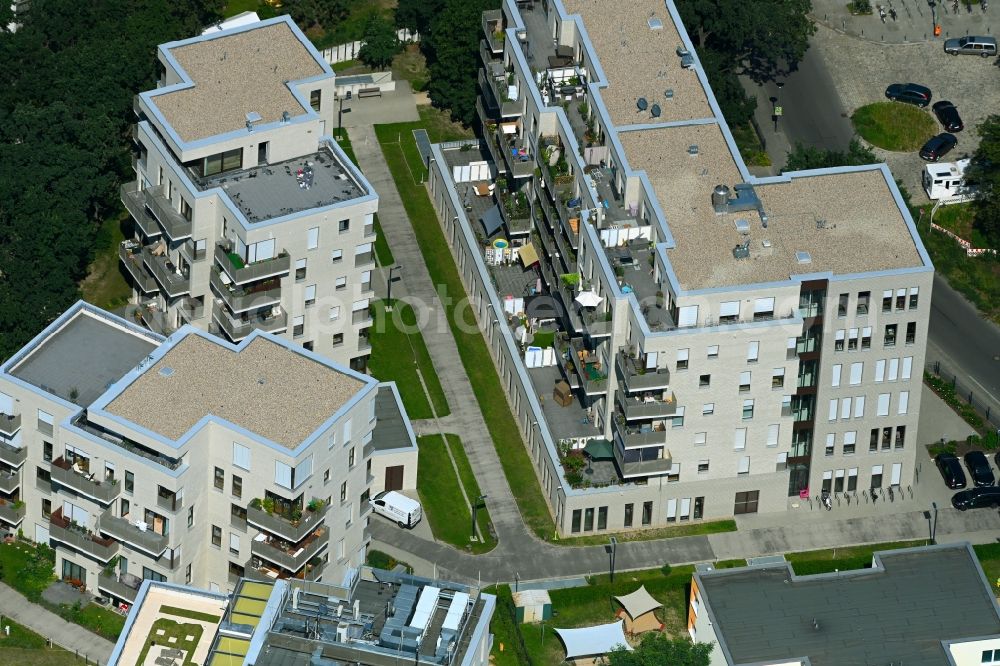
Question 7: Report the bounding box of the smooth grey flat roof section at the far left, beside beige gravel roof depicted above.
[8,306,161,406]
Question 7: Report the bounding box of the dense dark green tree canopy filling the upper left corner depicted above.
[0,0,211,359]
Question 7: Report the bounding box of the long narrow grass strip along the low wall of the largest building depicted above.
[373,116,555,538]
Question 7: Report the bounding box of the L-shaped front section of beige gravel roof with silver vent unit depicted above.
[619,123,923,290]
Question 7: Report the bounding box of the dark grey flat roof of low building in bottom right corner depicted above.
[696,544,1000,666]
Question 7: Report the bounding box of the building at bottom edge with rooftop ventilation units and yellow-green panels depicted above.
[108,567,496,666]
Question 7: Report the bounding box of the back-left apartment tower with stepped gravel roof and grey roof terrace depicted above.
[120,16,378,370]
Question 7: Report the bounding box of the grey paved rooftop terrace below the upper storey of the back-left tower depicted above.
[197,141,365,223]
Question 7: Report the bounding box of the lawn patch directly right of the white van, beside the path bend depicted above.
[417,435,496,553]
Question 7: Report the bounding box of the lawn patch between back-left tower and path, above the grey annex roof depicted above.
[368,301,451,419]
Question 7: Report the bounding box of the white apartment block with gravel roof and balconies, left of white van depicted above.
[0,302,416,603]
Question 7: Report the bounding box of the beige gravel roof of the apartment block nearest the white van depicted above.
[106,331,364,449]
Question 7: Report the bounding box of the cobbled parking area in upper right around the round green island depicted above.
[812,8,1000,202]
